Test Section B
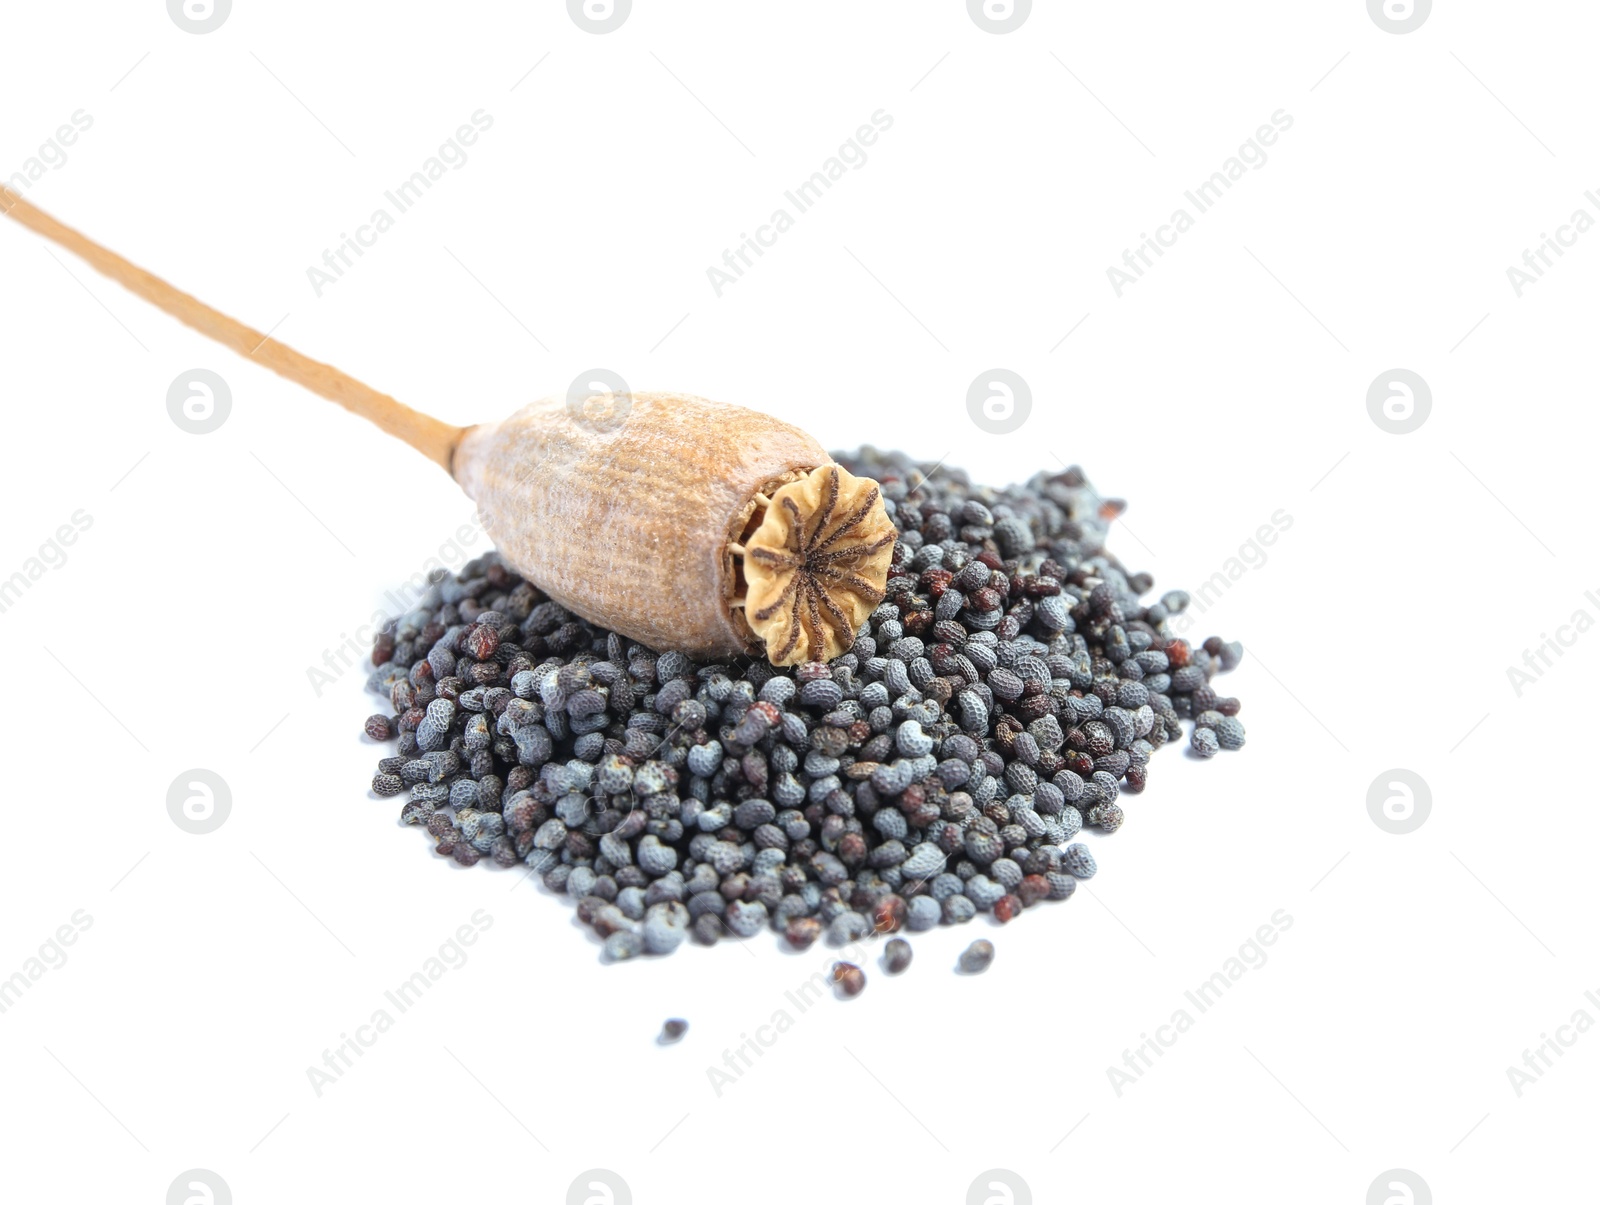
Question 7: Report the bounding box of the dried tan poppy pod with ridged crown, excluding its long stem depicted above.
[453,394,894,664]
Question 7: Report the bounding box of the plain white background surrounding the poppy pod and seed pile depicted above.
[0,0,1600,1205]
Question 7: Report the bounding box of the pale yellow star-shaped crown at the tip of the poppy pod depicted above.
[744,464,894,666]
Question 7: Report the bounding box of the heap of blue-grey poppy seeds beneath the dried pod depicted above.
[366,448,1245,959]
